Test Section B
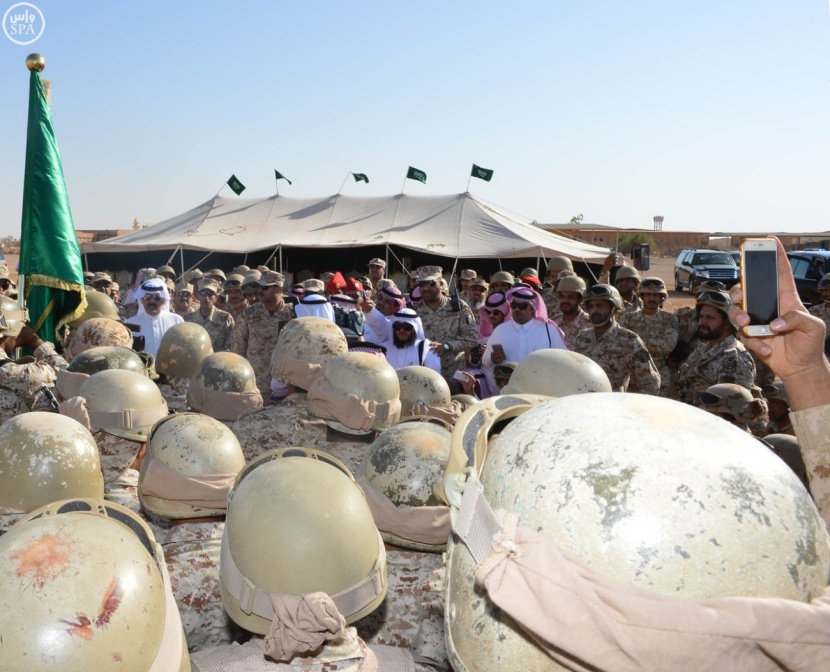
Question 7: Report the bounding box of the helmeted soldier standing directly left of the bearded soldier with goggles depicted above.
[620,278,680,397]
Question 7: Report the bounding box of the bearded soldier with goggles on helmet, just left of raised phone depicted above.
[677,292,755,404]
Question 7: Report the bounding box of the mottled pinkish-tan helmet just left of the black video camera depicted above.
[271,317,349,390]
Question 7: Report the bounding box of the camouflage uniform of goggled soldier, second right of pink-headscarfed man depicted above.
[573,320,660,394]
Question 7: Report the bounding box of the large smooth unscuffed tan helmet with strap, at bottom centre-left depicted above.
[220,448,387,634]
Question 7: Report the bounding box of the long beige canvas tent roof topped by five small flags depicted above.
[82,193,608,262]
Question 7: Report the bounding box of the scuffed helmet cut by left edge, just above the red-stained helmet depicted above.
[0,411,104,513]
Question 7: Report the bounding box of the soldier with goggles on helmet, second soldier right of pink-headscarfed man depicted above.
[573,284,660,394]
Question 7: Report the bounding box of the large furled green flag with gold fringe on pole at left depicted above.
[20,70,86,343]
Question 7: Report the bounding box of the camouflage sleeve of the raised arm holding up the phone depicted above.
[790,406,830,528]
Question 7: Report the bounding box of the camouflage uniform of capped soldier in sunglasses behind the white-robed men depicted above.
[415,295,478,376]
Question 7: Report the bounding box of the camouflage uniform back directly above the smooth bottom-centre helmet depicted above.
[233,394,369,474]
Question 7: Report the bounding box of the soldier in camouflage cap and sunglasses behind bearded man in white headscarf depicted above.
[415,266,478,376]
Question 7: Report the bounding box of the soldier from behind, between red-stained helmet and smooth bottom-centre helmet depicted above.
[138,413,245,652]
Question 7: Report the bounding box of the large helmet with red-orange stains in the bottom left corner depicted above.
[0,499,190,672]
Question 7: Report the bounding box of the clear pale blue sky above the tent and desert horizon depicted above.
[0,0,830,236]
